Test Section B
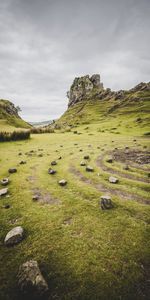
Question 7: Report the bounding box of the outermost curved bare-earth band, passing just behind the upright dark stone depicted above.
[69,166,150,205]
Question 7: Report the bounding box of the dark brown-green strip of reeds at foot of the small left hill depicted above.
[0,130,30,142]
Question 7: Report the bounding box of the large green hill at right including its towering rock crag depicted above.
[52,75,150,134]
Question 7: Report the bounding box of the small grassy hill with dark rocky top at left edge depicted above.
[0,99,31,131]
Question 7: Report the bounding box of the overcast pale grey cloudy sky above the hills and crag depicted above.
[0,0,150,122]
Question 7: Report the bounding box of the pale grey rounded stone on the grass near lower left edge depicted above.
[4,226,24,246]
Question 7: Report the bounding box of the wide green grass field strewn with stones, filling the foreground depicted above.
[0,120,150,300]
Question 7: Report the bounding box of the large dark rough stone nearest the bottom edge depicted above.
[17,260,48,300]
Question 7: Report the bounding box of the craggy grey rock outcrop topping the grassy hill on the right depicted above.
[67,74,103,107]
